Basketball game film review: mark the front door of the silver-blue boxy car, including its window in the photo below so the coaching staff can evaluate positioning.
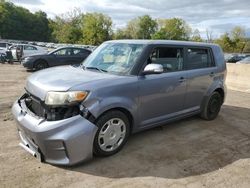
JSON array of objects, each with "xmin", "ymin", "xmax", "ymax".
[{"xmin": 138, "ymin": 46, "xmax": 187, "ymax": 127}]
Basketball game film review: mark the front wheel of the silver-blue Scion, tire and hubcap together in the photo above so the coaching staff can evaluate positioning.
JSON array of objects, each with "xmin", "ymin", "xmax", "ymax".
[{"xmin": 94, "ymin": 110, "xmax": 130, "ymax": 156}]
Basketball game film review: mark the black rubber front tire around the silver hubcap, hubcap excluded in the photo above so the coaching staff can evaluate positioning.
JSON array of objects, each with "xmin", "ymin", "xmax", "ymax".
[{"xmin": 93, "ymin": 110, "xmax": 130, "ymax": 156}]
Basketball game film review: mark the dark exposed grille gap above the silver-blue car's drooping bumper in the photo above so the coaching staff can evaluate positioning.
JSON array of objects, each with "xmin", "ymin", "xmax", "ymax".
[{"xmin": 24, "ymin": 94, "xmax": 80, "ymax": 121}]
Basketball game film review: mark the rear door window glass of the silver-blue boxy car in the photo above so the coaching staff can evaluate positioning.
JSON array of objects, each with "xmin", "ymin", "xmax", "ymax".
[{"xmin": 187, "ymin": 48, "xmax": 214, "ymax": 69}]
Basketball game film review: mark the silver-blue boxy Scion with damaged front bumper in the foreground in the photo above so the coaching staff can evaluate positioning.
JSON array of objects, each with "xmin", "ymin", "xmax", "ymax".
[{"xmin": 12, "ymin": 40, "xmax": 226, "ymax": 165}]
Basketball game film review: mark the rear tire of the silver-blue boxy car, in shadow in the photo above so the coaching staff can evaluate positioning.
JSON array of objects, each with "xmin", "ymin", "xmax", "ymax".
[{"xmin": 200, "ymin": 91, "xmax": 222, "ymax": 121}]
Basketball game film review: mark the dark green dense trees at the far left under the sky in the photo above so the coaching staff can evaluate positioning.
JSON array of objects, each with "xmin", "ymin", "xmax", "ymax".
[{"xmin": 0, "ymin": 0, "xmax": 51, "ymax": 41}]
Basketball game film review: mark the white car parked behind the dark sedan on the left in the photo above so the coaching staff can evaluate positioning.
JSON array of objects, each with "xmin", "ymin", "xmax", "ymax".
[{"xmin": 9, "ymin": 44, "xmax": 48, "ymax": 60}]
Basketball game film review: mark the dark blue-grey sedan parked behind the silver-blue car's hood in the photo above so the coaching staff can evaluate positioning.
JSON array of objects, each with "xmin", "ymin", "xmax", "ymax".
[{"xmin": 21, "ymin": 47, "xmax": 91, "ymax": 70}]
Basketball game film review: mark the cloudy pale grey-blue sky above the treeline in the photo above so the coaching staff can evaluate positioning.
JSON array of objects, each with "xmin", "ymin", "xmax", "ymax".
[{"xmin": 8, "ymin": 0, "xmax": 250, "ymax": 37}]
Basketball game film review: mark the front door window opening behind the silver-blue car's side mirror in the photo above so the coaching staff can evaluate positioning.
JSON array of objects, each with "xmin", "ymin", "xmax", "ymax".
[{"xmin": 149, "ymin": 47, "xmax": 183, "ymax": 72}]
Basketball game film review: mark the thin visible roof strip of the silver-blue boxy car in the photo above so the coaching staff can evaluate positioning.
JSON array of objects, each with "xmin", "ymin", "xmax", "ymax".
[{"xmin": 105, "ymin": 39, "xmax": 218, "ymax": 47}]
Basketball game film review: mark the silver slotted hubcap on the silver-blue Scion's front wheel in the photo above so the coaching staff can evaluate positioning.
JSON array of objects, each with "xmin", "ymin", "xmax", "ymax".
[{"xmin": 98, "ymin": 118, "xmax": 126, "ymax": 151}]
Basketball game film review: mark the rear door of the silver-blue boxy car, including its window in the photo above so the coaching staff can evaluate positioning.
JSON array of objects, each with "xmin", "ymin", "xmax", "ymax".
[{"xmin": 185, "ymin": 47, "xmax": 217, "ymax": 110}]
